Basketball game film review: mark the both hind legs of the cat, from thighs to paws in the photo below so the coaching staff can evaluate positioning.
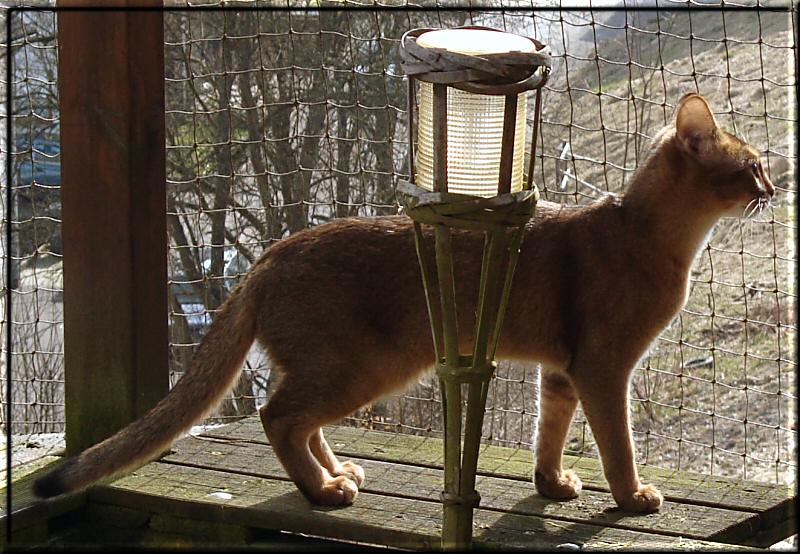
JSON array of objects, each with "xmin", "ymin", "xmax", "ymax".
[{"xmin": 260, "ymin": 317, "xmax": 433, "ymax": 504}]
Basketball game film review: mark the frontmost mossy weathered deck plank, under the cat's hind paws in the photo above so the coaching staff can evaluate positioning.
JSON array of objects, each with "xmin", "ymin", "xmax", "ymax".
[{"xmin": 94, "ymin": 462, "xmax": 752, "ymax": 550}]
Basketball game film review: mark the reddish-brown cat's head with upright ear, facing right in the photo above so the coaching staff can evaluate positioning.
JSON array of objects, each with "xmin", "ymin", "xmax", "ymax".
[{"xmin": 674, "ymin": 93, "xmax": 775, "ymax": 216}]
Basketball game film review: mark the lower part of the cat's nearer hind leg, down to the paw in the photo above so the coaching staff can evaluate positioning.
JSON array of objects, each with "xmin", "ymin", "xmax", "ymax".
[{"xmin": 259, "ymin": 383, "xmax": 358, "ymax": 506}]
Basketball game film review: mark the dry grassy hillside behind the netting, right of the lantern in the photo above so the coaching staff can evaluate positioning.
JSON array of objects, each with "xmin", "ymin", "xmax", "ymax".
[{"xmin": 536, "ymin": 8, "xmax": 796, "ymax": 480}]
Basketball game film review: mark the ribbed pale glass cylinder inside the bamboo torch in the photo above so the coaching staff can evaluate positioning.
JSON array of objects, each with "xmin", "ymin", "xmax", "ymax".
[{"xmin": 416, "ymin": 81, "xmax": 528, "ymax": 197}]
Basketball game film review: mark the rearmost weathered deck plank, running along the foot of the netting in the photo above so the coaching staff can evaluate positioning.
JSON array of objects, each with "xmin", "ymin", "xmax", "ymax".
[{"xmin": 204, "ymin": 418, "xmax": 796, "ymax": 522}]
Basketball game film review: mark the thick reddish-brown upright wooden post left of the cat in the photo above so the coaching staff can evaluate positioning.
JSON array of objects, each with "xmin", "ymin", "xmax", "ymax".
[{"xmin": 58, "ymin": 0, "xmax": 169, "ymax": 455}]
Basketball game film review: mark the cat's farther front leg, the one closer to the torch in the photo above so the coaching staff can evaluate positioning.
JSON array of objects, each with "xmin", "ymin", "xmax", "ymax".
[{"xmin": 534, "ymin": 367, "xmax": 582, "ymax": 500}]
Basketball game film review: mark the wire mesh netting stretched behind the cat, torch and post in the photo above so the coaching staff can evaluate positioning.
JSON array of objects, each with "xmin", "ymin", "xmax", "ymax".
[{"xmin": 0, "ymin": 2, "xmax": 797, "ymax": 490}]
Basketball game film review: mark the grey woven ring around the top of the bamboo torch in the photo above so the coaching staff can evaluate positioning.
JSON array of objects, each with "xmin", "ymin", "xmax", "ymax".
[{"xmin": 400, "ymin": 26, "xmax": 551, "ymax": 95}]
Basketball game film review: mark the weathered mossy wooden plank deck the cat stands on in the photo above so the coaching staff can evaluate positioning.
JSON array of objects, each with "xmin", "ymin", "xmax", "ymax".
[{"xmin": 3, "ymin": 418, "xmax": 797, "ymax": 550}]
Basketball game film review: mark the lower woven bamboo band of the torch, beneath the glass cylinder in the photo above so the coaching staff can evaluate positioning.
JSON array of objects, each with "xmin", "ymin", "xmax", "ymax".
[{"xmin": 397, "ymin": 181, "xmax": 539, "ymax": 231}]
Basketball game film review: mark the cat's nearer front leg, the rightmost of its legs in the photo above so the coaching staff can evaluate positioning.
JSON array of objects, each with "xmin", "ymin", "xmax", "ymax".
[{"xmin": 570, "ymin": 356, "xmax": 664, "ymax": 512}]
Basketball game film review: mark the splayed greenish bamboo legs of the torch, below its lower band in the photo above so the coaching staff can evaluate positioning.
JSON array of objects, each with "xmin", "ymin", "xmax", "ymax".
[{"xmin": 415, "ymin": 223, "xmax": 523, "ymax": 550}]
